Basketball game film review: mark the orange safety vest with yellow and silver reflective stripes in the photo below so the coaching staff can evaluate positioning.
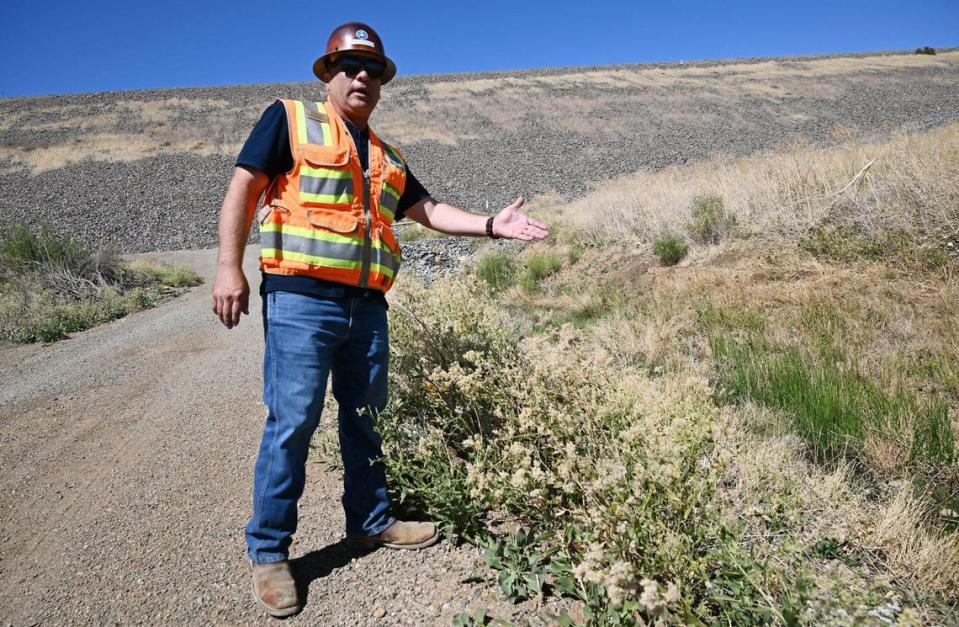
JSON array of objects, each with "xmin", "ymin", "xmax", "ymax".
[{"xmin": 260, "ymin": 100, "xmax": 406, "ymax": 292}]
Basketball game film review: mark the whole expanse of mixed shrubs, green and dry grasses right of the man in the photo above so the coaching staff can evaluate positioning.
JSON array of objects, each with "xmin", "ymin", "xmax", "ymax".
[{"xmin": 378, "ymin": 121, "xmax": 959, "ymax": 625}]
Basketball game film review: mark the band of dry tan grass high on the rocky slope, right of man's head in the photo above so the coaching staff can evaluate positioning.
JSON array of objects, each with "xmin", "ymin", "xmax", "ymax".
[{"xmin": 378, "ymin": 52, "xmax": 959, "ymax": 144}]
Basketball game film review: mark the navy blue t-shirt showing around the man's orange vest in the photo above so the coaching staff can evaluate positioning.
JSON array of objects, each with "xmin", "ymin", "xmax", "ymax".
[{"xmin": 236, "ymin": 102, "xmax": 430, "ymax": 298}]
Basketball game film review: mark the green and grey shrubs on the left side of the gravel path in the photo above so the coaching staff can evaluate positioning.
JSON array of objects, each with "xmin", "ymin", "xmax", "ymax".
[{"xmin": 0, "ymin": 225, "xmax": 201, "ymax": 342}]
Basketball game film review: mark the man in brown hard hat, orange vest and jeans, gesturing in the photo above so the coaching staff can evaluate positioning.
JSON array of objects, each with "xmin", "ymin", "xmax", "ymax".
[{"xmin": 213, "ymin": 23, "xmax": 547, "ymax": 616}]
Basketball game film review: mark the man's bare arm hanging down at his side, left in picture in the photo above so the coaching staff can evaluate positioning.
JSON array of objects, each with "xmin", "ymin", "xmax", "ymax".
[{"xmin": 213, "ymin": 166, "xmax": 270, "ymax": 329}]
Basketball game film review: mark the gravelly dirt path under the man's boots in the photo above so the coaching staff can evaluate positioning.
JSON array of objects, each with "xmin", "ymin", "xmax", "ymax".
[{"xmin": 0, "ymin": 251, "xmax": 564, "ymax": 625}]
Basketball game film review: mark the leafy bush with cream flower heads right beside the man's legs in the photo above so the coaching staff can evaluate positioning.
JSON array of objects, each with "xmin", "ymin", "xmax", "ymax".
[{"xmin": 378, "ymin": 286, "xmax": 844, "ymax": 625}]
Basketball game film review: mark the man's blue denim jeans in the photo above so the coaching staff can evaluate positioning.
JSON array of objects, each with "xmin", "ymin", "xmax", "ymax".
[{"xmin": 246, "ymin": 292, "xmax": 394, "ymax": 564}]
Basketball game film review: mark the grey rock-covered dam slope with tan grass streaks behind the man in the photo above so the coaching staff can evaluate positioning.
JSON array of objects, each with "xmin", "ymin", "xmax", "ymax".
[{"xmin": 0, "ymin": 50, "xmax": 959, "ymax": 252}]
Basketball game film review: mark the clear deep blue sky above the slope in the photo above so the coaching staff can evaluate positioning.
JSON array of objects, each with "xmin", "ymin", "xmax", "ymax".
[{"xmin": 0, "ymin": 0, "xmax": 959, "ymax": 97}]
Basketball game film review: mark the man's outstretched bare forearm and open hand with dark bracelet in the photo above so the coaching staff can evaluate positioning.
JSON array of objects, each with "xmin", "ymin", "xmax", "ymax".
[{"xmin": 405, "ymin": 196, "xmax": 549, "ymax": 240}]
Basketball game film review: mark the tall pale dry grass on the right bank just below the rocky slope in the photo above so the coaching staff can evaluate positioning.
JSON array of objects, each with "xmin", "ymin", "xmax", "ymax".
[{"xmin": 560, "ymin": 124, "xmax": 959, "ymax": 248}]
